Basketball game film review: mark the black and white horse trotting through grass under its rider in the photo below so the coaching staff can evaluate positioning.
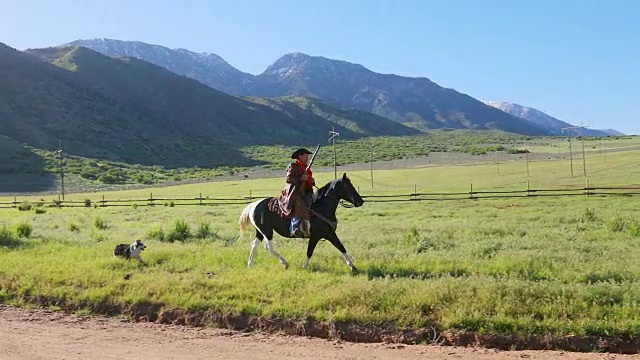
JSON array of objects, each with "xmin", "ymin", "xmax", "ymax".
[{"xmin": 238, "ymin": 173, "xmax": 364, "ymax": 273}]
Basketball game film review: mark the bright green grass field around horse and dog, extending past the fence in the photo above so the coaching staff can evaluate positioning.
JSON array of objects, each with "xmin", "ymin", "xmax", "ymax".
[{"xmin": 0, "ymin": 140, "xmax": 640, "ymax": 346}]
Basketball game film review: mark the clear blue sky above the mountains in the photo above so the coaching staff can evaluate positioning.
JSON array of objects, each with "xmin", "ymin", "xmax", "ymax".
[{"xmin": 0, "ymin": 0, "xmax": 640, "ymax": 134}]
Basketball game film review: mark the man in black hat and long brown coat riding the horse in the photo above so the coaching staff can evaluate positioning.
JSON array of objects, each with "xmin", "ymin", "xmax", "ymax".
[{"xmin": 279, "ymin": 148, "xmax": 315, "ymax": 237}]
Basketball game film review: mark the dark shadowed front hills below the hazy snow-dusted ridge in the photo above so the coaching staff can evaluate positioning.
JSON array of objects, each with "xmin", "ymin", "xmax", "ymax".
[{"xmin": 0, "ymin": 44, "xmax": 418, "ymax": 167}]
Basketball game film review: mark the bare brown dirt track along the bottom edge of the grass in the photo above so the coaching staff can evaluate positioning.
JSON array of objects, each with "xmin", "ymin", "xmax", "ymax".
[{"xmin": 0, "ymin": 305, "xmax": 638, "ymax": 360}]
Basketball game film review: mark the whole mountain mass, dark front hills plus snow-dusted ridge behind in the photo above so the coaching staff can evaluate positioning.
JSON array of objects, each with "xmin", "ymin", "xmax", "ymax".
[{"xmin": 0, "ymin": 39, "xmax": 620, "ymax": 174}]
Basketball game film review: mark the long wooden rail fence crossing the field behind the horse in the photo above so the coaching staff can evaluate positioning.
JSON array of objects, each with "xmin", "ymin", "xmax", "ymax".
[{"xmin": 0, "ymin": 184, "xmax": 640, "ymax": 209}]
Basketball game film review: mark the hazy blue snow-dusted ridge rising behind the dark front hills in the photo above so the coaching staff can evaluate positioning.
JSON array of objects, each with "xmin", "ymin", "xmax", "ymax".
[{"xmin": 65, "ymin": 39, "xmax": 549, "ymax": 135}]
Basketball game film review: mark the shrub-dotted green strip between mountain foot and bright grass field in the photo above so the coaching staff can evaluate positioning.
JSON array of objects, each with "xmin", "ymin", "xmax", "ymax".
[{"xmin": 7, "ymin": 130, "xmax": 640, "ymax": 193}]
